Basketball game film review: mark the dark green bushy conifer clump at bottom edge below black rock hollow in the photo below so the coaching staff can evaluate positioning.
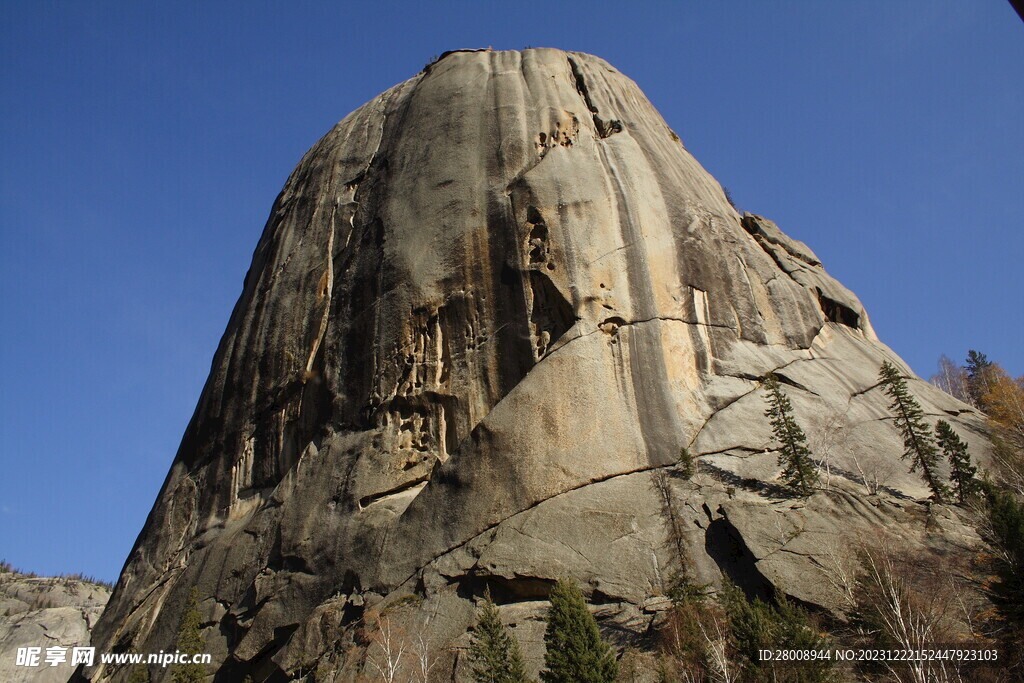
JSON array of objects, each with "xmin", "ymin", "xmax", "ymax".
[{"xmin": 721, "ymin": 583, "xmax": 835, "ymax": 683}]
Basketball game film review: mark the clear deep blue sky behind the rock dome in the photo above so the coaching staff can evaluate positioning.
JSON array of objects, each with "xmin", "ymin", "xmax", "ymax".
[{"xmin": 0, "ymin": 0, "xmax": 1024, "ymax": 580}]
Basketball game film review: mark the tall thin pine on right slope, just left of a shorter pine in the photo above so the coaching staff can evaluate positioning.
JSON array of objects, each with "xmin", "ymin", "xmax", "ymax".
[{"xmin": 879, "ymin": 360, "xmax": 949, "ymax": 503}]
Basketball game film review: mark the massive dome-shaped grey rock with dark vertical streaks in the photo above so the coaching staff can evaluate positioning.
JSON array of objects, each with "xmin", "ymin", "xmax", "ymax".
[{"xmin": 86, "ymin": 49, "xmax": 984, "ymax": 681}]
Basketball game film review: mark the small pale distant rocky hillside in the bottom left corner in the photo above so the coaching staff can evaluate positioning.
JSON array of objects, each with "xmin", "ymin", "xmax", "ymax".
[{"xmin": 0, "ymin": 570, "xmax": 111, "ymax": 683}]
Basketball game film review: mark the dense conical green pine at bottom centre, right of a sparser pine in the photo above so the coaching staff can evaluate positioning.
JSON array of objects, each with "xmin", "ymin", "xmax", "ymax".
[{"xmin": 541, "ymin": 579, "xmax": 618, "ymax": 683}]
